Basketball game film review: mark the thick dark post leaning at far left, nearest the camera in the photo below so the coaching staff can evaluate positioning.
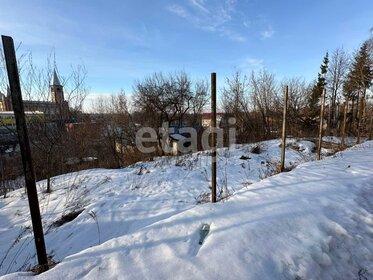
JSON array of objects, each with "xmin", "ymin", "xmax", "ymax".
[{"xmin": 1, "ymin": 35, "xmax": 48, "ymax": 271}]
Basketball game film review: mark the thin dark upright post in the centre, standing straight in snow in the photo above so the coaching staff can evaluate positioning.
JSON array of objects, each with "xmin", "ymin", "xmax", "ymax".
[{"xmin": 211, "ymin": 73, "xmax": 216, "ymax": 203}]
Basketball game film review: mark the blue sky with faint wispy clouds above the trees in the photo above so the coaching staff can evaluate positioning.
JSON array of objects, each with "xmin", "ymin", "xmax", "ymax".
[{"xmin": 0, "ymin": 0, "xmax": 373, "ymax": 107}]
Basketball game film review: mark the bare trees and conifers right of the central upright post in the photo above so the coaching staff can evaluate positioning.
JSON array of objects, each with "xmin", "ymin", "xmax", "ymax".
[{"xmin": 222, "ymin": 31, "xmax": 373, "ymax": 142}]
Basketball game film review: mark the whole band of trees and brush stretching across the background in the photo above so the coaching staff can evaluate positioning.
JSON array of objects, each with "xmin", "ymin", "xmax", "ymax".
[{"xmin": 0, "ymin": 30, "xmax": 373, "ymax": 191}]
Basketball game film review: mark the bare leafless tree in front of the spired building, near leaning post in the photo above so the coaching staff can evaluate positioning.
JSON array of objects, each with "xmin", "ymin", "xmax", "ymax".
[{"xmin": 0, "ymin": 48, "xmax": 88, "ymax": 192}]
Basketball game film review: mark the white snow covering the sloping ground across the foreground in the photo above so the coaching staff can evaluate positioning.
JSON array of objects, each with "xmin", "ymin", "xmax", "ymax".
[{"xmin": 0, "ymin": 139, "xmax": 373, "ymax": 280}]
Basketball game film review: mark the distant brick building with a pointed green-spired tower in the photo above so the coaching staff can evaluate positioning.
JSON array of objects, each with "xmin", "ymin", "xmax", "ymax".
[{"xmin": 0, "ymin": 70, "xmax": 69, "ymax": 121}]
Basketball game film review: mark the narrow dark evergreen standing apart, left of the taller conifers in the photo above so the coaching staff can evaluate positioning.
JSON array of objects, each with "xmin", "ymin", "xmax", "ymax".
[{"xmin": 308, "ymin": 53, "xmax": 329, "ymax": 118}]
